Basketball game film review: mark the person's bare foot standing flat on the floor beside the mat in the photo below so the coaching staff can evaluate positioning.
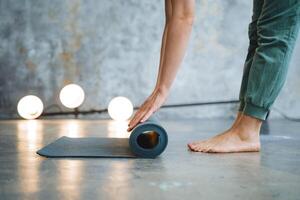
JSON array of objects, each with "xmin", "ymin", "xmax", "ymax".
[{"xmin": 188, "ymin": 114, "xmax": 262, "ymax": 153}]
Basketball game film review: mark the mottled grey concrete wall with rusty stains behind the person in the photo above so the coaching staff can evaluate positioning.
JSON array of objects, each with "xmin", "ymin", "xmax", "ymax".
[{"xmin": 0, "ymin": 0, "xmax": 300, "ymax": 118}]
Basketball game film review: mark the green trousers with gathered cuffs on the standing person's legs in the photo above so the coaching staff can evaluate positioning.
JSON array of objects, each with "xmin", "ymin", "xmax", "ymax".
[{"xmin": 239, "ymin": 0, "xmax": 300, "ymax": 120}]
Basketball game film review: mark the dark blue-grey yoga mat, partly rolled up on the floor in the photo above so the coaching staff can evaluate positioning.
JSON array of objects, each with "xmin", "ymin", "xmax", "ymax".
[{"xmin": 37, "ymin": 117, "xmax": 168, "ymax": 158}]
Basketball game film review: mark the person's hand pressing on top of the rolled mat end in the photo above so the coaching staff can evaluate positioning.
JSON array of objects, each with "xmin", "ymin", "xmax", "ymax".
[{"xmin": 127, "ymin": 91, "xmax": 167, "ymax": 131}]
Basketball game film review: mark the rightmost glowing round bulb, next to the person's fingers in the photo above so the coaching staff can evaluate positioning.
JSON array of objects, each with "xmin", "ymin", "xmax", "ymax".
[{"xmin": 108, "ymin": 97, "xmax": 133, "ymax": 121}]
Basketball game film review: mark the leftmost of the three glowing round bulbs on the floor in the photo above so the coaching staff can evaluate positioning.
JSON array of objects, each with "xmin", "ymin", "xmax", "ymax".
[{"xmin": 17, "ymin": 95, "xmax": 44, "ymax": 119}]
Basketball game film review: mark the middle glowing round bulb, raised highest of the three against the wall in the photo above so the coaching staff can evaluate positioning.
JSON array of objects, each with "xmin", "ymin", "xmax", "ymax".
[{"xmin": 59, "ymin": 84, "xmax": 84, "ymax": 108}]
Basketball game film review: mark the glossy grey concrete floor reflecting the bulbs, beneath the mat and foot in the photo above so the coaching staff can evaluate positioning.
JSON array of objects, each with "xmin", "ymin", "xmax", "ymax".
[{"xmin": 0, "ymin": 120, "xmax": 300, "ymax": 200}]
